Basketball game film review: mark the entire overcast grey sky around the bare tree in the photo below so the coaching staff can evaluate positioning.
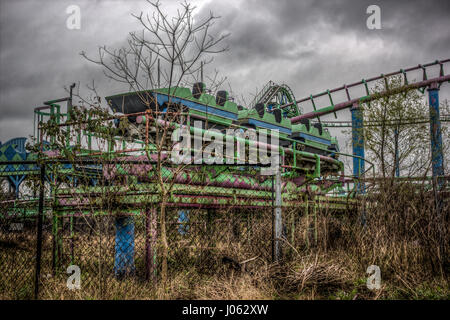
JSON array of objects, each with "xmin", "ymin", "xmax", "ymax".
[{"xmin": 0, "ymin": 0, "xmax": 450, "ymax": 162}]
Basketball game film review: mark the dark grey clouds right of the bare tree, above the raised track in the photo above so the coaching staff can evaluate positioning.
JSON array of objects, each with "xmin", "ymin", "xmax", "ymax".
[{"xmin": 197, "ymin": 0, "xmax": 450, "ymax": 95}]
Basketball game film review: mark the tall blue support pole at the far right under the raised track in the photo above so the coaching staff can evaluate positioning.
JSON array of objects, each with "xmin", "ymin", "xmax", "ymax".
[{"xmin": 428, "ymin": 83, "xmax": 444, "ymax": 187}]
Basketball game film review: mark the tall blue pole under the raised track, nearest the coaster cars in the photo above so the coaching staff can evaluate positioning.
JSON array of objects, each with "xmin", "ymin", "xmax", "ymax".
[{"xmin": 350, "ymin": 103, "xmax": 364, "ymax": 193}]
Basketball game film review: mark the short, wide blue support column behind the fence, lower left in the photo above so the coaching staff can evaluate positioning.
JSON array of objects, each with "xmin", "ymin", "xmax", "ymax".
[{"xmin": 114, "ymin": 217, "xmax": 135, "ymax": 277}]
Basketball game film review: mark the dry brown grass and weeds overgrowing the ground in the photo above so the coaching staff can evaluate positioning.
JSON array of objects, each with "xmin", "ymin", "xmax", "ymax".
[{"xmin": 0, "ymin": 180, "xmax": 450, "ymax": 300}]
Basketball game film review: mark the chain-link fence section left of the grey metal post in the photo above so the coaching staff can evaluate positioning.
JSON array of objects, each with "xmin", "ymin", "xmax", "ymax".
[{"xmin": 0, "ymin": 160, "xmax": 286, "ymax": 299}]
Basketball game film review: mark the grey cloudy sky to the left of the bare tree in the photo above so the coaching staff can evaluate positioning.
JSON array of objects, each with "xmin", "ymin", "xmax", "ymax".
[{"xmin": 0, "ymin": 0, "xmax": 141, "ymax": 141}]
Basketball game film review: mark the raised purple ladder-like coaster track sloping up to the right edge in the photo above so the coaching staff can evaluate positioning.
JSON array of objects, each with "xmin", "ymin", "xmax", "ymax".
[{"xmin": 280, "ymin": 59, "xmax": 450, "ymax": 124}]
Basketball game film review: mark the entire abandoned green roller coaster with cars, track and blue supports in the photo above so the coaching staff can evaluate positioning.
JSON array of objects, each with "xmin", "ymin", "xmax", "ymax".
[{"xmin": 0, "ymin": 59, "xmax": 450, "ymax": 272}]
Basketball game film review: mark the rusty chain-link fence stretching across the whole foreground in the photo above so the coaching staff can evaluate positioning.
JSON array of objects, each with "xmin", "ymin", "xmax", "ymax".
[{"xmin": 6, "ymin": 158, "xmax": 442, "ymax": 300}]
